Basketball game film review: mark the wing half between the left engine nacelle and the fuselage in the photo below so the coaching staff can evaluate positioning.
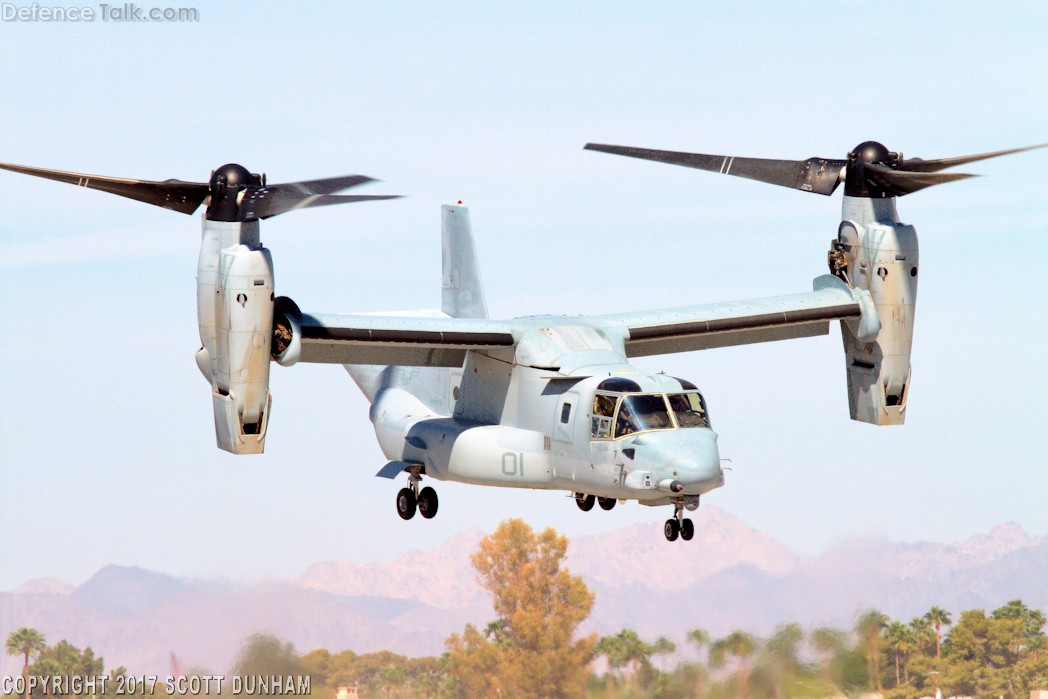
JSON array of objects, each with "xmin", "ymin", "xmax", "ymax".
[{"xmin": 296, "ymin": 313, "xmax": 516, "ymax": 367}]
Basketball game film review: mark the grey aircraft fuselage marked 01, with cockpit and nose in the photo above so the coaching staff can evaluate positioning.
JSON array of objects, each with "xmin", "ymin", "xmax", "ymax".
[{"xmin": 349, "ymin": 326, "xmax": 724, "ymax": 507}]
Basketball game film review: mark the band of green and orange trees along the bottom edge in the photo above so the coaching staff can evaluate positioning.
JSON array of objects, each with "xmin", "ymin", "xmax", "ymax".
[{"xmin": 3, "ymin": 553, "xmax": 1048, "ymax": 699}]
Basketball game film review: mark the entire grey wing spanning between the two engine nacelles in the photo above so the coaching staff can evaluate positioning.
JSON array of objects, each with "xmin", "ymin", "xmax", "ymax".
[{"xmin": 275, "ymin": 275, "xmax": 880, "ymax": 367}]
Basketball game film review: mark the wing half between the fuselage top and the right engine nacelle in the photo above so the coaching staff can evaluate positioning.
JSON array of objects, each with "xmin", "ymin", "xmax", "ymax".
[{"xmin": 588, "ymin": 275, "xmax": 880, "ymax": 356}]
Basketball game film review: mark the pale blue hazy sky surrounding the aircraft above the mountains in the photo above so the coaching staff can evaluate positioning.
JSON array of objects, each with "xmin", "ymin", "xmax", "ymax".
[{"xmin": 0, "ymin": 0, "xmax": 1048, "ymax": 590}]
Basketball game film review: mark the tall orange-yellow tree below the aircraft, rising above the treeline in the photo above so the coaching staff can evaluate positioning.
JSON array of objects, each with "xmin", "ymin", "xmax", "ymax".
[{"xmin": 446, "ymin": 520, "xmax": 596, "ymax": 697}]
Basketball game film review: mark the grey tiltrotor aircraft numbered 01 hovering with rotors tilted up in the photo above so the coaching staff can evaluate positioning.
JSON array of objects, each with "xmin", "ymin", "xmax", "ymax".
[{"xmin": 0, "ymin": 141, "xmax": 1041, "ymax": 541}]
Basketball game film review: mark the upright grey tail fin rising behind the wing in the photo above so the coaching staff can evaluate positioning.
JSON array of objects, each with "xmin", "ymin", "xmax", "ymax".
[{"xmin": 440, "ymin": 204, "xmax": 487, "ymax": 318}]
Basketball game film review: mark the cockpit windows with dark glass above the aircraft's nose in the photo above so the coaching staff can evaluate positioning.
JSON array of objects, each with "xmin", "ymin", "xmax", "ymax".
[{"xmin": 590, "ymin": 377, "xmax": 709, "ymax": 439}]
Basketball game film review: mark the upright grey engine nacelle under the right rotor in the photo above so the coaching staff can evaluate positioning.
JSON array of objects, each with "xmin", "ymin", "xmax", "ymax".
[{"xmin": 834, "ymin": 196, "xmax": 918, "ymax": 424}]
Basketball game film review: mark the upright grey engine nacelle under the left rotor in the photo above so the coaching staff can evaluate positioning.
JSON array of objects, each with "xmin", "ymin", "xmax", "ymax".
[{"xmin": 197, "ymin": 220, "xmax": 274, "ymax": 454}]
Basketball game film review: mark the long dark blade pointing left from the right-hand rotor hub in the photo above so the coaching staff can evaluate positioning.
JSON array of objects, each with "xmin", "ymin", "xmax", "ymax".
[{"xmin": 586, "ymin": 144, "xmax": 848, "ymax": 196}]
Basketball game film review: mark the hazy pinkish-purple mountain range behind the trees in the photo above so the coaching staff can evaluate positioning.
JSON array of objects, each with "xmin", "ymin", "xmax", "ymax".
[{"xmin": 0, "ymin": 507, "xmax": 1048, "ymax": 675}]
